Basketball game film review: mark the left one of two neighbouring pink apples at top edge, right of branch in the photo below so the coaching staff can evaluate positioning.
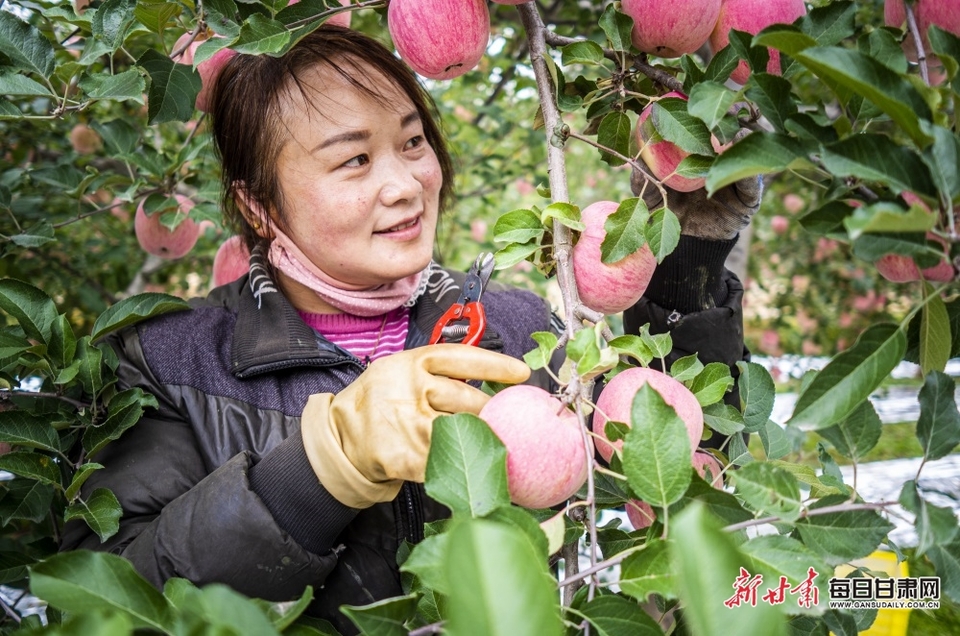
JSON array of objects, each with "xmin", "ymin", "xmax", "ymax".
[{"xmin": 621, "ymin": 0, "xmax": 720, "ymax": 57}]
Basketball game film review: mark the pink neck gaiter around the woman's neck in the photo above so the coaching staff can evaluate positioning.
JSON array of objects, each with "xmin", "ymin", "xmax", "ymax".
[{"xmin": 267, "ymin": 223, "xmax": 430, "ymax": 316}]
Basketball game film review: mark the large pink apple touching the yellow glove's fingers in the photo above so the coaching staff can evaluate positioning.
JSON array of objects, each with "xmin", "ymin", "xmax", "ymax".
[{"xmin": 480, "ymin": 385, "xmax": 593, "ymax": 508}]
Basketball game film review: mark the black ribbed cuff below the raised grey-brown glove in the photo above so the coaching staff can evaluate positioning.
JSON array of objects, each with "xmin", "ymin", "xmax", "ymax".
[{"xmin": 643, "ymin": 235, "xmax": 737, "ymax": 314}]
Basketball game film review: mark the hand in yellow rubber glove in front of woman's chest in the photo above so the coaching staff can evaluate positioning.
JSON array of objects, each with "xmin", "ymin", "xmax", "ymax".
[{"xmin": 300, "ymin": 344, "xmax": 530, "ymax": 508}]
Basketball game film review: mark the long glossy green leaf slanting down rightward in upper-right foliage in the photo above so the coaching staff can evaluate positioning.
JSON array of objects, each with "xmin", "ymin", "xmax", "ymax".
[{"xmin": 793, "ymin": 46, "xmax": 932, "ymax": 147}]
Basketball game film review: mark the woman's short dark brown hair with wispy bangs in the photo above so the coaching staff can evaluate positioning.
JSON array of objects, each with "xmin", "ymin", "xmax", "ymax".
[{"xmin": 211, "ymin": 25, "xmax": 453, "ymax": 250}]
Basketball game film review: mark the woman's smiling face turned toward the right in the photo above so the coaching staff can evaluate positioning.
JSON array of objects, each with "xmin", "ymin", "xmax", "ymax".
[{"xmin": 277, "ymin": 67, "xmax": 443, "ymax": 287}]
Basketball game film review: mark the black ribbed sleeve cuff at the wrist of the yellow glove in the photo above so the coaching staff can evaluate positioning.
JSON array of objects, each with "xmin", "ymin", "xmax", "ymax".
[{"xmin": 248, "ymin": 434, "xmax": 359, "ymax": 554}]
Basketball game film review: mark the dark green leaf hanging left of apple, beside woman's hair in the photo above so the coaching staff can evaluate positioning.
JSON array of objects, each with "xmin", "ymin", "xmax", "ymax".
[{"xmin": 137, "ymin": 49, "xmax": 202, "ymax": 124}]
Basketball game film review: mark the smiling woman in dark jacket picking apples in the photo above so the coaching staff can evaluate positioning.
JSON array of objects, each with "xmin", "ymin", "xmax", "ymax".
[{"xmin": 62, "ymin": 26, "xmax": 756, "ymax": 633}]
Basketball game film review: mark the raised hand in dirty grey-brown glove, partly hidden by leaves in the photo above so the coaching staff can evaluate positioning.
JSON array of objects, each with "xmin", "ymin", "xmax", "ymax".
[{"xmin": 630, "ymin": 129, "xmax": 763, "ymax": 240}]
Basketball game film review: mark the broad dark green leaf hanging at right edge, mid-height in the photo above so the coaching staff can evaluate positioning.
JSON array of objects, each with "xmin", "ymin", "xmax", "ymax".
[{"xmin": 917, "ymin": 371, "xmax": 960, "ymax": 461}]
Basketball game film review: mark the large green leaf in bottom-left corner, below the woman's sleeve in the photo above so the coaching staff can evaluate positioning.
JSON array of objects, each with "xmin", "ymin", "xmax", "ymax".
[{"xmin": 30, "ymin": 550, "xmax": 173, "ymax": 633}]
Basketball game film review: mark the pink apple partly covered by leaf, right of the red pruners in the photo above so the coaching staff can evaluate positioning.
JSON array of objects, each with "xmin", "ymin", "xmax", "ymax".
[{"xmin": 573, "ymin": 201, "xmax": 657, "ymax": 314}]
